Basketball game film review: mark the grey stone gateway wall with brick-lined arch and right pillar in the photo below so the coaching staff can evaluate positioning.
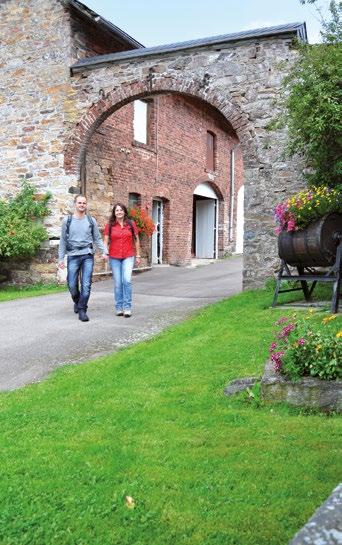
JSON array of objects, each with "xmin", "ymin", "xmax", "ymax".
[{"xmin": 66, "ymin": 37, "xmax": 302, "ymax": 287}]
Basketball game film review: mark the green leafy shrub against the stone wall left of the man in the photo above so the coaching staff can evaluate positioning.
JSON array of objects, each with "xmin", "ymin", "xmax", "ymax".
[{"xmin": 0, "ymin": 182, "xmax": 51, "ymax": 259}]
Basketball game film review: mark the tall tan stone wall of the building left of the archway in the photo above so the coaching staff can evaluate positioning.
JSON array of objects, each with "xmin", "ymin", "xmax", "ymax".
[{"xmin": 0, "ymin": 0, "xmax": 77, "ymax": 232}]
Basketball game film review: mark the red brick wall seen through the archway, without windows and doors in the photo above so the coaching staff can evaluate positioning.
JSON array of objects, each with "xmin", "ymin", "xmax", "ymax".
[{"xmin": 86, "ymin": 95, "xmax": 243, "ymax": 264}]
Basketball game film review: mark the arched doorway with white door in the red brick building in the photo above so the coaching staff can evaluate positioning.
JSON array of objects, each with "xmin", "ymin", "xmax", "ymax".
[{"xmin": 192, "ymin": 183, "xmax": 219, "ymax": 259}]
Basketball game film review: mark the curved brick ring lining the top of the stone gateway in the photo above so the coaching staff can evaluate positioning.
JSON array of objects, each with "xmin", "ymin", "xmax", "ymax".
[{"xmin": 64, "ymin": 76, "xmax": 253, "ymax": 179}]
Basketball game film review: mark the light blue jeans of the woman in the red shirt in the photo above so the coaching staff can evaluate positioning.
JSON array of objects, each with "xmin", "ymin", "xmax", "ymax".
[{"xmin": 109, "ymin": 257, "xmax": 134, "ymax": 310}]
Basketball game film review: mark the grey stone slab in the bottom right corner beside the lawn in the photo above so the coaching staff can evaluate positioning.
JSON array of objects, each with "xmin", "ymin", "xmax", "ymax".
[{"xmin": 289, "ymin": 483, "xmax": 342, "ymax": 545}]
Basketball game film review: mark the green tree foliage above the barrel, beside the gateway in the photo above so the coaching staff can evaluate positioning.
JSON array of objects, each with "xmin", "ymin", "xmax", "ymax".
[{"xmin": 284, "ymin": 0, "xmax": 342, "ymax": 187}]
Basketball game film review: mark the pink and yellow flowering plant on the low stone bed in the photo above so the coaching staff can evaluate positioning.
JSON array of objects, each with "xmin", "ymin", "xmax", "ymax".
[{"xmin": 269, "ymin": 312, "xmax": 342, "ymax": 380}]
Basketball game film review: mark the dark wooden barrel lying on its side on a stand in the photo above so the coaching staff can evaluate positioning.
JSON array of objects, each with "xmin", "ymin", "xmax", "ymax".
[{"xmin": 278, "ymin": 214, "xmax": 342, "ymax": 267}]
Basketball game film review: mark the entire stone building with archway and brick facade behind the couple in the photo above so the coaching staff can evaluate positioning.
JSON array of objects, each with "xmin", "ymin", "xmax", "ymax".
[{"xmin": 0, "ymin": 0, "xmax": 306, "ymax": 286}]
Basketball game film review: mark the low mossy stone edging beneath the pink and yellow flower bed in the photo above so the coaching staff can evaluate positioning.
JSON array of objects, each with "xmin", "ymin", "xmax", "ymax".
[{"xmin": 261, "ymin": 361, "xmax": 342, "ymax": 412}]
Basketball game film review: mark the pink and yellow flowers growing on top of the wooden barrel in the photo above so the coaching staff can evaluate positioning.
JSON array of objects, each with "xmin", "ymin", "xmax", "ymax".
[{"xmin": 274, "ymin": 185, "xmax": 342, "ymax": 235}]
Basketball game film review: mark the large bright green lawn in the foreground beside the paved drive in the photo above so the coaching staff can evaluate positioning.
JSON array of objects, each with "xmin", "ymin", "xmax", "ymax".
[{"xmin": 0, "ymin": 291, "xmax": 342, "ymax": 545}]
